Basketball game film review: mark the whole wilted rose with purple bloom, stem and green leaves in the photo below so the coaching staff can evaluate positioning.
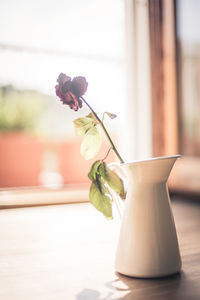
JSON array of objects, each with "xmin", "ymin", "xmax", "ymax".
[{"xmin": 55, "ymin": 73, "xmax": 125, "ymax": 219}]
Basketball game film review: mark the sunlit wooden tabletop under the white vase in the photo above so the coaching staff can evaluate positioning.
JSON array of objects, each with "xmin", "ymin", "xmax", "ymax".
[{"xmin": 0, "ymin": 199, "xmax": 200, "ymax": 300}]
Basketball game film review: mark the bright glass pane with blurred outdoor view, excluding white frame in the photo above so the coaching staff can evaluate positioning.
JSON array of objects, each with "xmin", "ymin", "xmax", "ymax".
[{"xmin": 0, "ymin": 0, "xmax": 126, "ymax": 192}]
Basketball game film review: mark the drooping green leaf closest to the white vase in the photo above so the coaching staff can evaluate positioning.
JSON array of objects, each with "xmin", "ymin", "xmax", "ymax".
[{"xmin": 98, "ymin": 163, "xmax": 125, "ymax": 199}]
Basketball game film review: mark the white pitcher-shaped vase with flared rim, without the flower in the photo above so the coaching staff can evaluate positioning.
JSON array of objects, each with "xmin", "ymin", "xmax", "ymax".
[{"xmin": 115, "ymin": 155, "xmax": 181, "ymax": 278}]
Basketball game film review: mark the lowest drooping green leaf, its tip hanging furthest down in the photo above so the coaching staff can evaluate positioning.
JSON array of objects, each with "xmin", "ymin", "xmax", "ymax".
[{"xmin": 89, "ymin": 182, "xmax": 112, "ymax": 219}]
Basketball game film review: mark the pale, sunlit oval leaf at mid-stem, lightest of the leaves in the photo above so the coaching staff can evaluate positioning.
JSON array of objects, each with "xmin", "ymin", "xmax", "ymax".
[{"xmin": 80, "ymin": 127, "xmax": 101, "ymax": 160}]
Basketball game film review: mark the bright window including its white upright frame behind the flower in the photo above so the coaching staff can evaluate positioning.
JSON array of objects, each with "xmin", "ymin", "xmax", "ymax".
[{"xmin": 0, "ymin": 0, "xmax": 151, "ymax": 205}]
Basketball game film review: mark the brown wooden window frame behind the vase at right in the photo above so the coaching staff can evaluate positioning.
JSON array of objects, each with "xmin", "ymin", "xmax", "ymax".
[{"xmin": 149, "ymin": 0, "xmax": 200, "ymax": 197}]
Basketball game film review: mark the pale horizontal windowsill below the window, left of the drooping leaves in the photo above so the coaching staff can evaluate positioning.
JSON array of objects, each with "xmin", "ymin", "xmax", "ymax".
[{"xmin": 0, "ymin": 185, "xmax": 89, "ymax": 208}]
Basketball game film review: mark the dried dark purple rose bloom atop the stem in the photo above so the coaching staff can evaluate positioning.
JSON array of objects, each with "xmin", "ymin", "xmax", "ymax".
[{"xmin": 55, "ymin": 73, "xmax": 88, "ymax": 111}]
